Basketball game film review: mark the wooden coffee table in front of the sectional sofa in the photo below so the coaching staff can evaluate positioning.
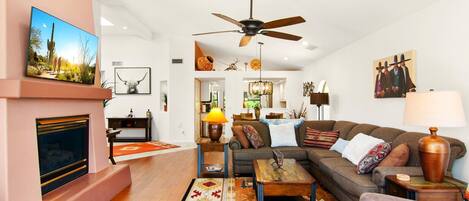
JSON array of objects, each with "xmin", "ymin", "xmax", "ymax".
[{"xmin": 253, "ymin": 159, "xmax": 317, "ymax": 201}]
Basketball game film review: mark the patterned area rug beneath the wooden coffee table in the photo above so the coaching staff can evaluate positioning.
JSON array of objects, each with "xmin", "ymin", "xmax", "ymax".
[{"xmin": 182, "ymin": 177, "xmax": 336, "ymax": 201}]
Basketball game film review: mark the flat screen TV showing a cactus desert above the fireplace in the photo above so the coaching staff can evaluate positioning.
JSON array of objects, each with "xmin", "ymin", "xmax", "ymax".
[{"xmin": 26, "ymin": 7, "xmax": 98, "ymax": 85}]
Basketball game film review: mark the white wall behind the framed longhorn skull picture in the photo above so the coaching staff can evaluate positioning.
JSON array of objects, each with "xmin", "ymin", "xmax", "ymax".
[{"xmin": 101, "ymin": 35, "xmax": 169, "ymax": 139}]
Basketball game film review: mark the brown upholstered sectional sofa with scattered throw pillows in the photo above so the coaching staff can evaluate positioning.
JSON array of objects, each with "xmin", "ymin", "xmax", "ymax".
[{"xmin": 230, "ymin": 121, "xmax": 466, "ymax": 201}]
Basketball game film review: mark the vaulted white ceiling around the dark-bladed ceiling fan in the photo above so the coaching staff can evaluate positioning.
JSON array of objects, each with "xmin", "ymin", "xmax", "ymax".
[{"xmin": 100, "ymin": 0, "xmax": 438, "ymax": 70}]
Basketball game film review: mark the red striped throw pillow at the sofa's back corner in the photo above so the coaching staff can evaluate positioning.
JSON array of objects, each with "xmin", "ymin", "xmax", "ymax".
[{"xmin": 303, "ymin": 127, "xmax": 339, "ymax": 149}]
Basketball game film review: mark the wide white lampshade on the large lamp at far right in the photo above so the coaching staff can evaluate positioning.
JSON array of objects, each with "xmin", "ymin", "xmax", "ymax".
[{"xmin": 404, "ymin": 91, "xmax": 466, "ymax": 127}]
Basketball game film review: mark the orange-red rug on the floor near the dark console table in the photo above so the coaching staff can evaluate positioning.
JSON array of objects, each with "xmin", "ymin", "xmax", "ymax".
[{"xmin": 114, "ymin": 141, "xmax": 179, "ymax": 156}]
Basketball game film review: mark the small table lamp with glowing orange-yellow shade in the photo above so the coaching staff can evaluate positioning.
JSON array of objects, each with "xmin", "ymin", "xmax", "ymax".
[{"xmin": 202, "ymin": 107, "xmax": 228, "ymax": 142}]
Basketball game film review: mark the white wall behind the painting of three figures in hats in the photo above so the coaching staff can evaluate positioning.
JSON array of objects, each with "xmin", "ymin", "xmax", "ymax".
[{"xmin": 305, "ymin": 0, "xmax": 469, "ymax": 182}]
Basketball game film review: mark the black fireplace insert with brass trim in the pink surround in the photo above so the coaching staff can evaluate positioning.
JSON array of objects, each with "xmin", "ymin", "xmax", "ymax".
[{"xmin": 36, "ymin": 115, "xmax": 89, "ymax": 195}]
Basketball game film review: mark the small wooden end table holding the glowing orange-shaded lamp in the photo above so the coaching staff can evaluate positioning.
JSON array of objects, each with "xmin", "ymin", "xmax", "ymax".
[{"xmin": 196, "ymin": 136, "xmax": 229, "ymax": 178}]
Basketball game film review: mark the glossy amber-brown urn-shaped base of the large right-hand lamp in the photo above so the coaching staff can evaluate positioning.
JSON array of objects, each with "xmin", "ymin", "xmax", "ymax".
[{"xmin": 419, "ymin": 128, "xmax": 451, "ymax": 183}]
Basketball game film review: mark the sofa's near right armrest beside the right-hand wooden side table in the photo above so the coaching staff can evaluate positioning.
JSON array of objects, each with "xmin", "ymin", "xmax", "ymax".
[{"xmin": 371, "ymin": 167, "xmax": 423, "ymax": 187}]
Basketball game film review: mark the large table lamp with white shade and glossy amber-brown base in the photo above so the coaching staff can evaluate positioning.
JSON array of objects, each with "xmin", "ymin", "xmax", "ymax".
[{"xmin": 404, "ymin": 90, "xmax": 466, "ymax": 183}]
